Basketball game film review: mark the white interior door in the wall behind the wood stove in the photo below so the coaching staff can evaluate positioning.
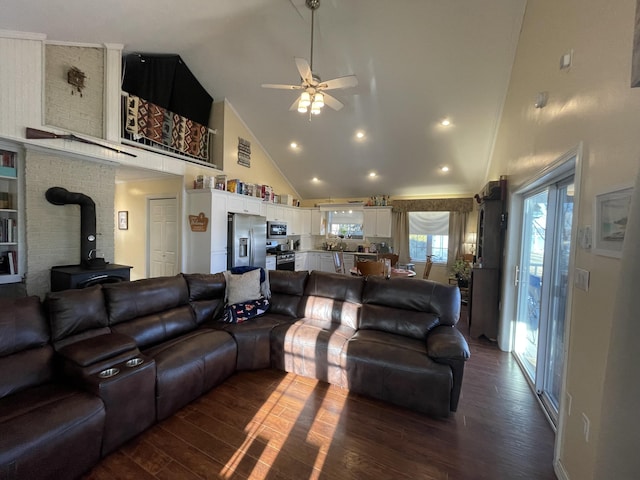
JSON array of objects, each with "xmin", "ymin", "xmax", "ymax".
[{"xmin": 147, "ymin": 198, "xmax": 178, "ymax": 277}]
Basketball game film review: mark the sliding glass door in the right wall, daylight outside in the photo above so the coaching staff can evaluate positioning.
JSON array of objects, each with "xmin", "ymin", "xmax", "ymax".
[{"xmin": 514, "ymin": 175, "xmax": 573, "ymax": 421}]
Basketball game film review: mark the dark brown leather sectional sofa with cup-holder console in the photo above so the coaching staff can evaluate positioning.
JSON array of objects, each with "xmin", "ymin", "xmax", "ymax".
[{"xmin": 0, "ymin": 271, "xmax": 469, "ymax": 480}]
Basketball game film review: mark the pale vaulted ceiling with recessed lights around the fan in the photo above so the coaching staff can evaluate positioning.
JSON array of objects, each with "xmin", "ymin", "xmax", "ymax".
[{"xmin": 0, "ymin": 0, "xmax": 533, "ymax": 198}]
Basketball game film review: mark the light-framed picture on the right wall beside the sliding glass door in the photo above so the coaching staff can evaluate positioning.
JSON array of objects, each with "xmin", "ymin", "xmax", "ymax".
[{"xmin": 593, "ymin": 187, "xmax": 633, "ymax": 258}]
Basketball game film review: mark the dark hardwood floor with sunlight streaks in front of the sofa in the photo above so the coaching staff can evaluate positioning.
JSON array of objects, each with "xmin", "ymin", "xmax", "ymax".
[{"xmin": 85, "ymin": 310, "xmax": 556, "ymax": 480}]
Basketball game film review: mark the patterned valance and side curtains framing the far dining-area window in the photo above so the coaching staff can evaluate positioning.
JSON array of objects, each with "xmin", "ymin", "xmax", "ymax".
[{"xmin": 392, "ymin": 198, "xmax": 474, "ymax": 268}]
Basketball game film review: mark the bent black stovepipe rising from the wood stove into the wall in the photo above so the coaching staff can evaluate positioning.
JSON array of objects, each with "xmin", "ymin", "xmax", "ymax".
[{"xmin": 45, "ymin": 187, "xmax": 105, "ymax": 269}]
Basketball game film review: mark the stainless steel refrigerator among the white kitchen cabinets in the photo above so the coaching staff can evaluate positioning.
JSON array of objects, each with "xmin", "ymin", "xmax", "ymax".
[{"xmin": 227, "ymin": 213, "xmax": 267, "ymax": 268}]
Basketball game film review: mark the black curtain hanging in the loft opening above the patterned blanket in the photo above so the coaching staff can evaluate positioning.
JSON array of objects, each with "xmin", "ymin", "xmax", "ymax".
[{"xmin": 122, "ymin": 53, "xmax": 213, "ymax": 126}]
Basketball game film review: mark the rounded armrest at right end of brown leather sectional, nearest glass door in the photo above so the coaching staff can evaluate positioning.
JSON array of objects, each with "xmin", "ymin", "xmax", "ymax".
[{"xmin": 427, "ymin": 325, "xmax": 471, "ymax": 412}]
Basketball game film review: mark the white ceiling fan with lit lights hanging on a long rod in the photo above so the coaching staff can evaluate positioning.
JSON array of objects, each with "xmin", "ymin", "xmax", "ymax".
[{"xmin": 262, "ymin": 0, "xmax": 358, "ymax": 118}]
